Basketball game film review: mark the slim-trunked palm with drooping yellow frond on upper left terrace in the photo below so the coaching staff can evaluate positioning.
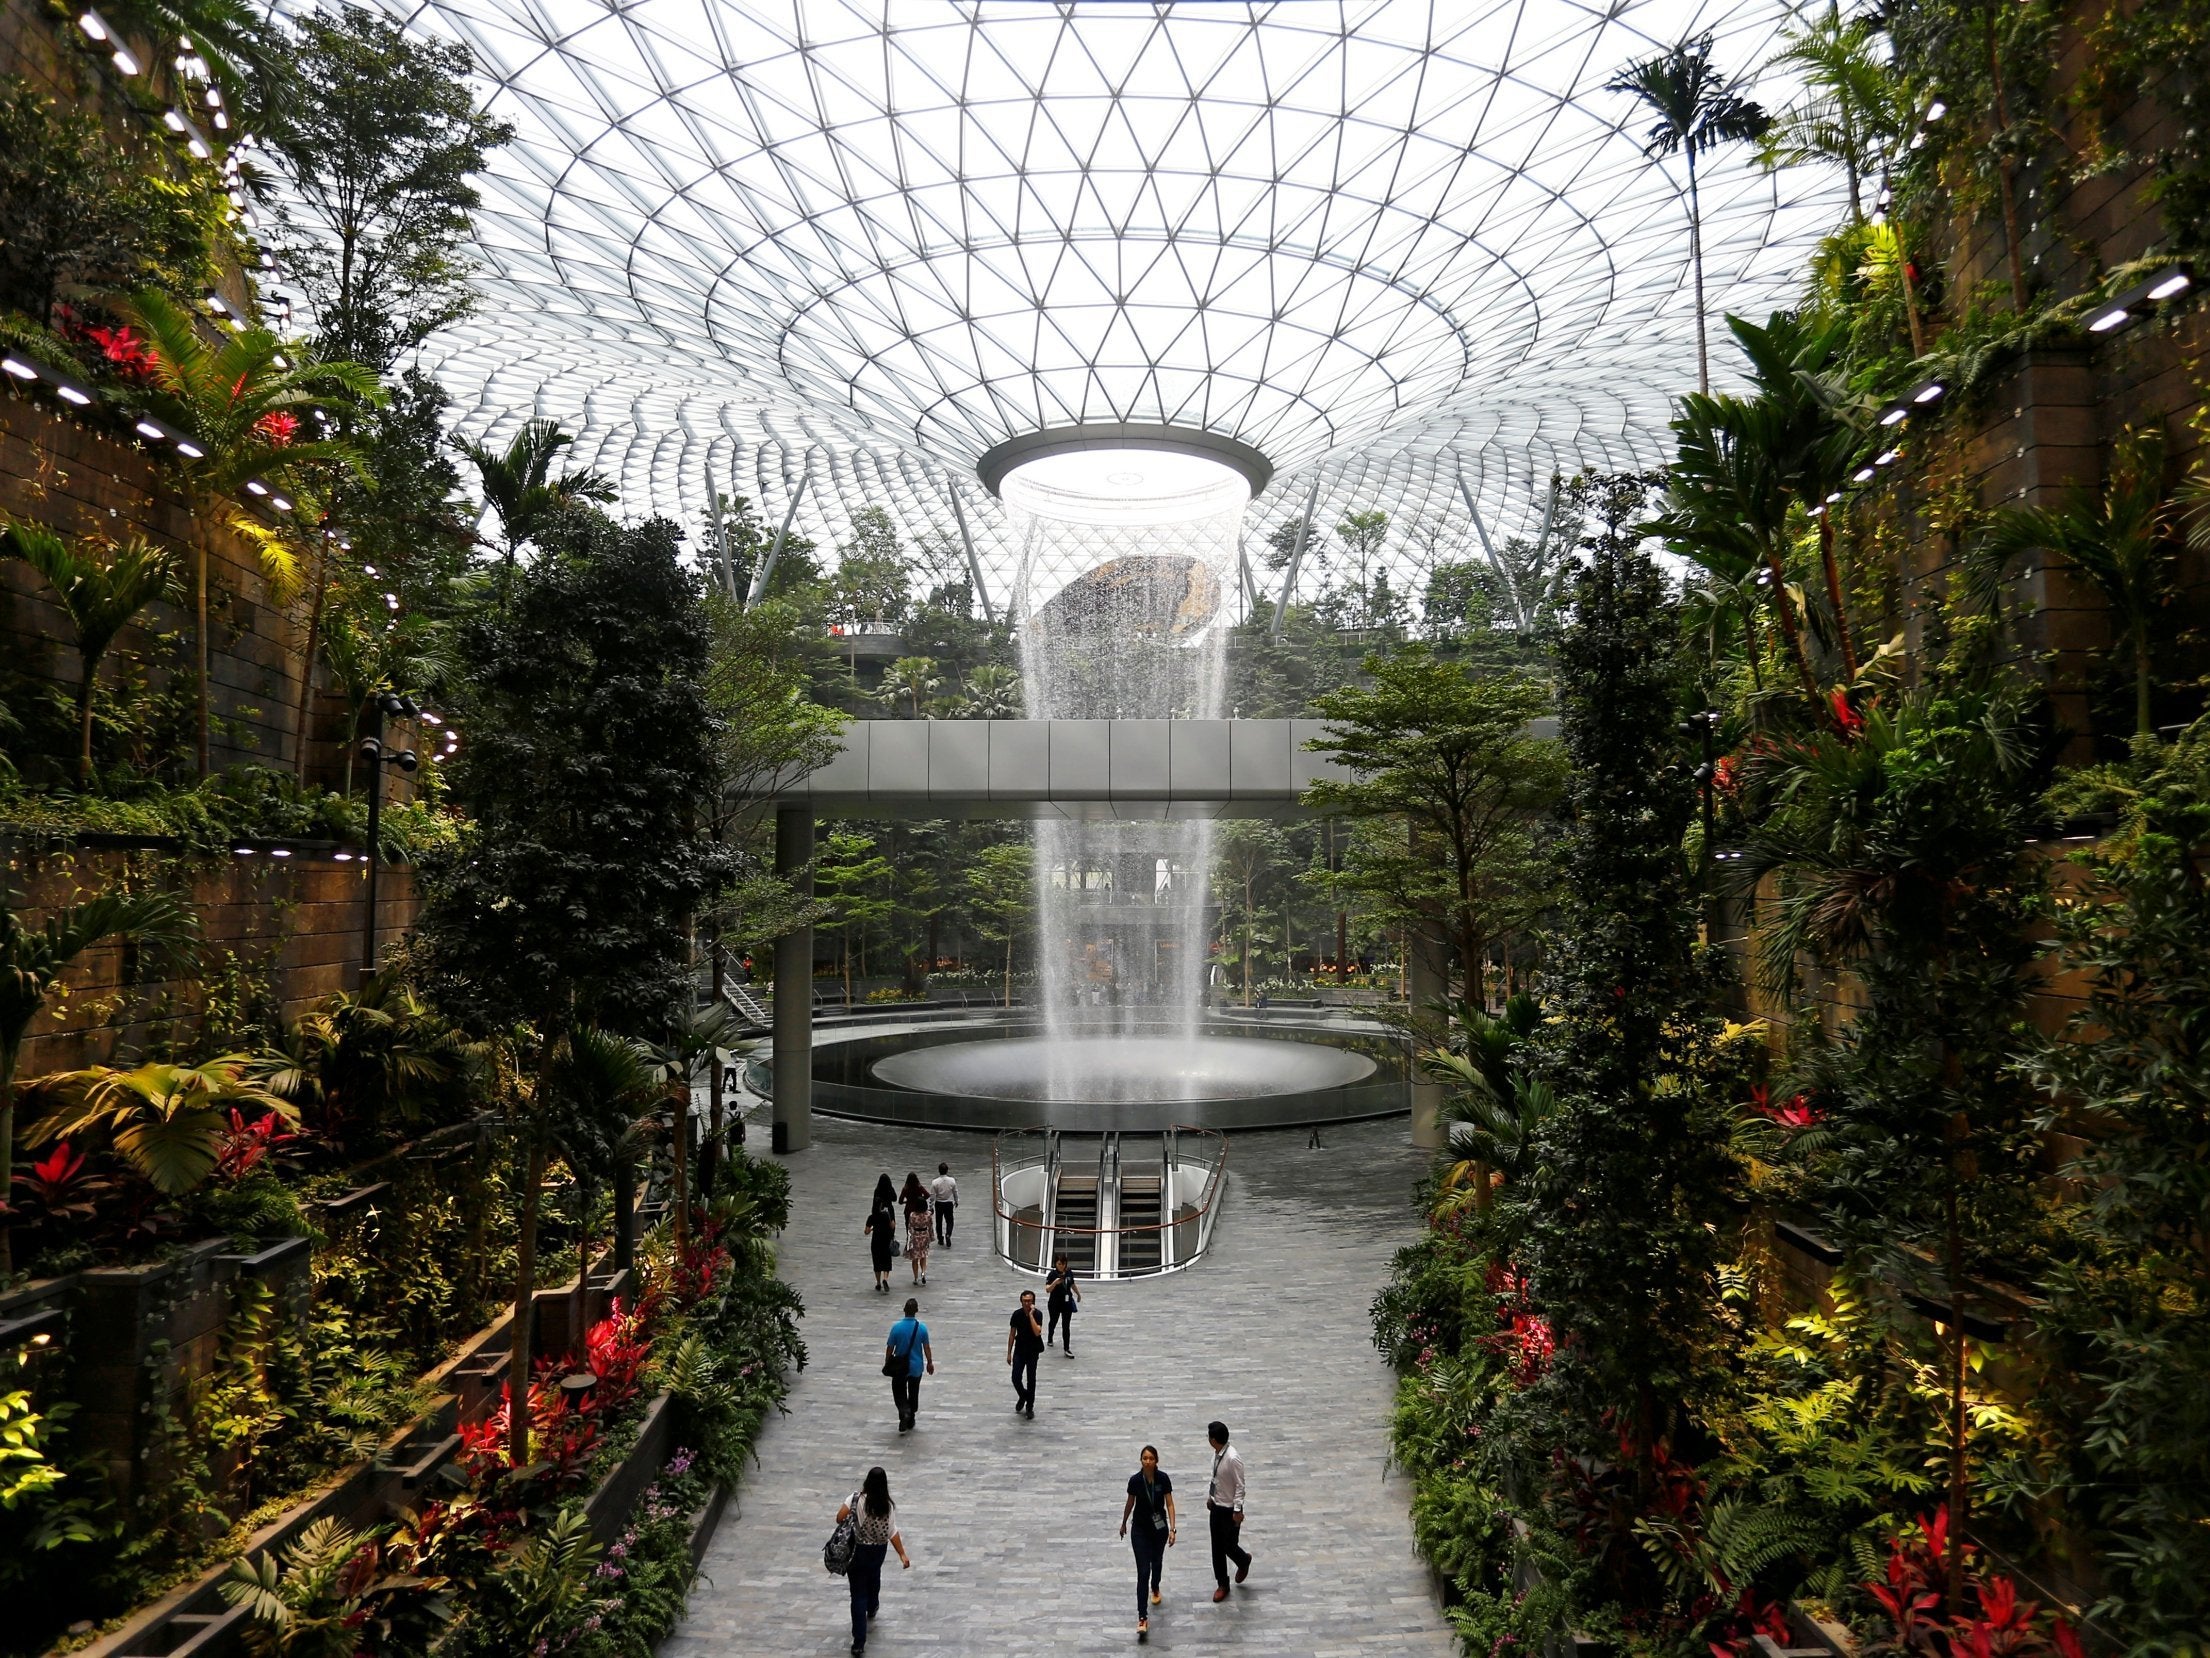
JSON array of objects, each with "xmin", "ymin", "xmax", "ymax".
[{"xmin": 128, "ymin": 290, "xmax": 385, "ymax": 776}]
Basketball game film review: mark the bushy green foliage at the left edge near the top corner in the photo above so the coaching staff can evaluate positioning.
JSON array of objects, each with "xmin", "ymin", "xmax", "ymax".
[{"xmin": 0, "ymin": 75, "xmax": 214, "ymax": 327}]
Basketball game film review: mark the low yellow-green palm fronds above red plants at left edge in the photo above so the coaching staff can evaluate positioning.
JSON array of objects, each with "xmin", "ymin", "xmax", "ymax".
[{"xmin": 31, "ymin": 1054, "xmax": 298, "ymax": 1198}]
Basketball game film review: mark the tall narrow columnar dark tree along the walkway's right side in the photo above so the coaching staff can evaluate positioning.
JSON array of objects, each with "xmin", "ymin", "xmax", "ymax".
[{"xmin": 1525, "ymin": 475, "xmax": 1728, "ymax": 1503}]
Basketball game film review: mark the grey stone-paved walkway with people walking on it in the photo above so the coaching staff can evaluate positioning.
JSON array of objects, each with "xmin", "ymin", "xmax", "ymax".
[{"xmin": 663, "ymin": 1112, "xmax": 1454, "ymax": 1658}]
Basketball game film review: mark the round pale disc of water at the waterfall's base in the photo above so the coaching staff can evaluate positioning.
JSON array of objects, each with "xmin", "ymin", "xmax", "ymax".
[{"xmin": 871, "ymin": 1035, "xmax": 1375, "ymax": 1105}]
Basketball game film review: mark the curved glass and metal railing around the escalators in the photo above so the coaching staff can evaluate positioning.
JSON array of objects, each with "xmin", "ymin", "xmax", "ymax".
[{"xmin": 990, "ymin": 1125, "xmax": 1229, "ymax": 1278}]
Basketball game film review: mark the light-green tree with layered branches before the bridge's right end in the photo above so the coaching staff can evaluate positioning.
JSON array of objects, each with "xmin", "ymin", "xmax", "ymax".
[{"xmin": 1306, "ymin": 643, "xmax": 1562, "ymax": 1001}]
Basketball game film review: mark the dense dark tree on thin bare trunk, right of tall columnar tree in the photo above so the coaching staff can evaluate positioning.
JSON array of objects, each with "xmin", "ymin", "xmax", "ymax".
[{"xmin": 1737, "ymin": 683, "xmax": 2049, "ymax": 1605}]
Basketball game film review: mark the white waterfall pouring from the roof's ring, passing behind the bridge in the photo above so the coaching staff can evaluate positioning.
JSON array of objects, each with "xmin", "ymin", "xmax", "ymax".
[{"xmin": 1014, "ymin": 508, "xmax": 1242, "ymax": 1099}]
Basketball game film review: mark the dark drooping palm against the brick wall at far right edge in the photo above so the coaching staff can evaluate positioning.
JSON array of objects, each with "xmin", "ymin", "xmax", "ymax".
[{"xmin": 1974, "ymin": 429, "xmax": 2210, "ymax": 738}]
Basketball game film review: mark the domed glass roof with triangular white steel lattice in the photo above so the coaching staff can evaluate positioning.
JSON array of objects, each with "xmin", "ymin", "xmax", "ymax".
[{"xmin": 353, "ymin": 0, "xmax": 1839, "ymax": 610}]
